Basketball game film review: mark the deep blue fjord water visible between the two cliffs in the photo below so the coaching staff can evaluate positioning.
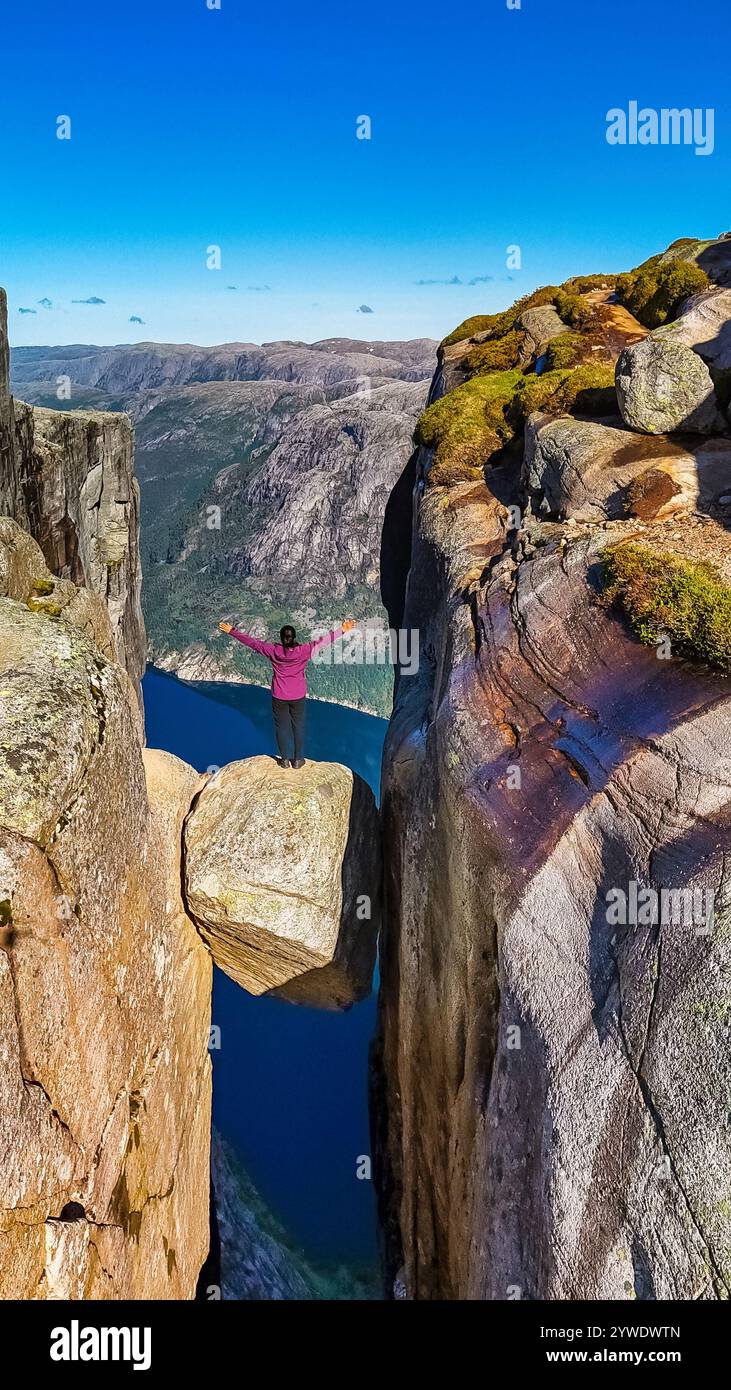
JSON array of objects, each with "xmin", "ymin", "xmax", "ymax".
[{"xmin": 143, "ymin": 669, "xmax": 386, "ymax": 1265}]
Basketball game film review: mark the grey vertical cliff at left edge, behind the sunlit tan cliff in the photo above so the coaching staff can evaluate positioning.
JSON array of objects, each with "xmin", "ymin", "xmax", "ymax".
[{"xmin": 0, "ymin": 293, "xmax": 146, "ymax": 684}]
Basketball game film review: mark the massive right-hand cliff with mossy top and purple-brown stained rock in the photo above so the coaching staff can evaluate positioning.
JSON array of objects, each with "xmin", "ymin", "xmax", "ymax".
[{"xmin": 374, "ymin": 230, "xmax": 731, "ymax": 1300}]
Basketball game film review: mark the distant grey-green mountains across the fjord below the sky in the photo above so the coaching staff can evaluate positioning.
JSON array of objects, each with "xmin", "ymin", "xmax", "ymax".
[{"xmin": 11, "ymin": 338, "xmax": 436, "ymax": 713}]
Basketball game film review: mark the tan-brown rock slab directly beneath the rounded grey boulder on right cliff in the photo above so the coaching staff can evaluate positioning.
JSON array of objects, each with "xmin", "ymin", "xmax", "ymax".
[{"xmin": 523, "ymin": 414, "xmax": 731, "ymax": 523}]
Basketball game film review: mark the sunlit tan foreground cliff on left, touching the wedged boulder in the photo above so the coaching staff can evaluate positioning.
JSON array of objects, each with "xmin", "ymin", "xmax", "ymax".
[{"xmin": 0, "ymin": 592, "xmax": 211, "ymax": 1300}]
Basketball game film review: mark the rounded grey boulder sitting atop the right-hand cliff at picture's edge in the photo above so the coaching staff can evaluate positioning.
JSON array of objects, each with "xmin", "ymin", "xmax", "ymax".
[{"xmin": 616, "ymin": 329, "xmax": 728, "ymax": 434}]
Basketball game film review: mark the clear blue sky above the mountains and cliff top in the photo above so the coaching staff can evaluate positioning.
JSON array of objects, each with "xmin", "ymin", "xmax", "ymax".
[{"xmin": 0, "ymin": 0, "xmax": 731, "ymax": 345}]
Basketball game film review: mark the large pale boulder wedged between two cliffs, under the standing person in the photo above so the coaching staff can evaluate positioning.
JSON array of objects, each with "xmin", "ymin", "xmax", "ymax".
[{"xmin": 185, "ymin": 758, "xmax": 381, "ymax": 1008}]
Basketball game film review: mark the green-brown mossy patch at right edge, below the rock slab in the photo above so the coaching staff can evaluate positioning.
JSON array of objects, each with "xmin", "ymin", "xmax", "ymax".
[{"xmin": 602, "ymin": 541, "xmax": 731, "ymax": 671}]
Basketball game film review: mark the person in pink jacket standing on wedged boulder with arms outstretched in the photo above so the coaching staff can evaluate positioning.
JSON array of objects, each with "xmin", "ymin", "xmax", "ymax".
[{"xmin": 218, "ymin": 619, "xmax": 356, "ymax": 767}]
